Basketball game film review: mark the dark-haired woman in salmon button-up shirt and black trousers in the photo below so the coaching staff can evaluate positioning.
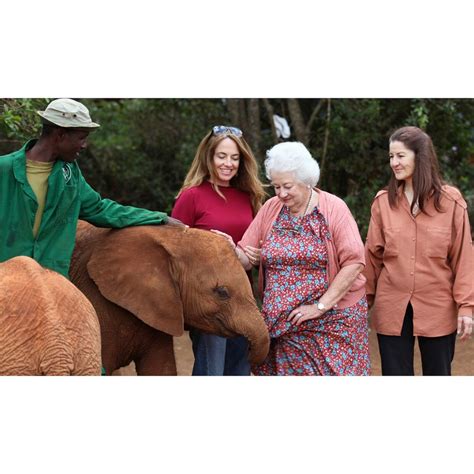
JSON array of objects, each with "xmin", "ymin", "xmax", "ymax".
[{"xmin": 365, "ymin": 127, "xmax": 474, "ymax": 375}]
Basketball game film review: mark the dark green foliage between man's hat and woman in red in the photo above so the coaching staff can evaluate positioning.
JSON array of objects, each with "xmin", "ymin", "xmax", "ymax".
[{"xmin": 81, "ymin": 99, "xmax": 227, "ymax": 212}]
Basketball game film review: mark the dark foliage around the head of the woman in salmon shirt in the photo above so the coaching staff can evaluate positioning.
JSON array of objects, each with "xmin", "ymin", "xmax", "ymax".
[{"xmin": 290, "ymin": 99, "xmax": 474, "ymax": 236}]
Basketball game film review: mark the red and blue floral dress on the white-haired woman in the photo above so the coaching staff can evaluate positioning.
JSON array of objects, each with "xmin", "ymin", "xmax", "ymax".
[{"xmin": 252, "ymin": 206, "xmax": 370, "ymax": 375}]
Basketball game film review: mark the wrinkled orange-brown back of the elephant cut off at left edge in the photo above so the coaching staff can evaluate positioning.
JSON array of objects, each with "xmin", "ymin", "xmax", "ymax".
[{"xmin": 0, "ymin": 257, "xmax": 101, "ymax": 375}]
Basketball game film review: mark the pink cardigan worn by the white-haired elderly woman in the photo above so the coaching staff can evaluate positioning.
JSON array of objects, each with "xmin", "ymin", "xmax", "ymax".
[{"xmin": 238, "ymin": 189, "xmax": 365, "ymax": 309}]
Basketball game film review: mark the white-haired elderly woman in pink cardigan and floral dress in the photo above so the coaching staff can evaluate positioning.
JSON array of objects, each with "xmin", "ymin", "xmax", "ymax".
[{"xmin": 230, "ymin": 142, "xmax": 370, "ymax": 375}]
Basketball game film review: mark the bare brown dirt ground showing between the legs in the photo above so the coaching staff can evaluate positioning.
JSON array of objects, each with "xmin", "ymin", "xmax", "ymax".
[{"xmin": 117, "ymin": 331, "xmax": 474, "ymax": 375}]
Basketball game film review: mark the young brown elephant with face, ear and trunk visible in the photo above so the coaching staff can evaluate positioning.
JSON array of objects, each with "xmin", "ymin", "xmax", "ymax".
[{"xmin": 70, "ymin": 221, "xmax": 269, "ymax": 375}]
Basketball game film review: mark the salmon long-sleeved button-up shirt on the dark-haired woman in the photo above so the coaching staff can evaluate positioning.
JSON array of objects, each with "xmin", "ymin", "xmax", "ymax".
[{"xmin": 364, "ymin": 186, "xmax": 474, "ymax": 337}]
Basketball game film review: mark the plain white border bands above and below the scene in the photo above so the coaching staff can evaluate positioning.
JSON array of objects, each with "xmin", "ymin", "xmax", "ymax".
[{"xmin": 0, "ymin": 0, "xmax": 474, "ymax": 474}]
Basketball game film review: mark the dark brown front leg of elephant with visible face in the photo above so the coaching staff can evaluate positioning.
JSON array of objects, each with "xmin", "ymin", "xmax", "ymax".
[{"xmin": 135, "ymin": 333, "xmax": 177, "ymax": 375}]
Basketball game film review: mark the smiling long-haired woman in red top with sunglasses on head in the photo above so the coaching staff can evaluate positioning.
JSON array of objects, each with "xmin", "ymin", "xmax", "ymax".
[{"xmin": 171, "ymin": 125, "xmax": 265, "ymax": 375}]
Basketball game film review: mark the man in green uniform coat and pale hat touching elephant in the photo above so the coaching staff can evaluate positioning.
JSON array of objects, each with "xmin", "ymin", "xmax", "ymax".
[{"xmin": 0, "ymin": 99, "xmax": 179, "ymax": 277}]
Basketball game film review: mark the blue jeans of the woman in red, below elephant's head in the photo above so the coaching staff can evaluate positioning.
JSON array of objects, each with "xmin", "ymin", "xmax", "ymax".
[{"xmin": 189, "ymin": 329, "xmax": 250, "ymax": 375}]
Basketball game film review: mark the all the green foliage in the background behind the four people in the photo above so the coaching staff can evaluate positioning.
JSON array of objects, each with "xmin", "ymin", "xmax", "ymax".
[{"xmin": 0, "ymin": 99, "xmax": 474, "ymax": 236}]
